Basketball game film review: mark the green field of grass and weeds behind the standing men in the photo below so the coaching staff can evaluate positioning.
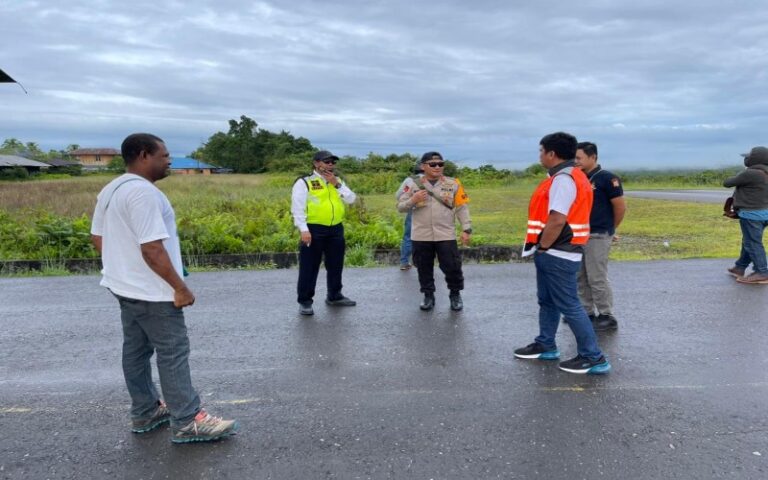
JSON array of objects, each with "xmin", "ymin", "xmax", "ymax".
[{"xmin": 0, "ymin": 174, "xmax": 741, "ymax": 264}]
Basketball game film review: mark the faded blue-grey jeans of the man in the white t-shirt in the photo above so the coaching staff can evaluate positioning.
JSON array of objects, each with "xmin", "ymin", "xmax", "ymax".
[{"xmin": 115, "ymin": 295, "xmax": 200, "ymax": 428}]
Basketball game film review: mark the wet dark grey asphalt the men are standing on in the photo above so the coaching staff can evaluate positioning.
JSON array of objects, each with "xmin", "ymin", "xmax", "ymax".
[{"xmin": 0, "ymin": 260, "xmax": 768, "ymax": 479}]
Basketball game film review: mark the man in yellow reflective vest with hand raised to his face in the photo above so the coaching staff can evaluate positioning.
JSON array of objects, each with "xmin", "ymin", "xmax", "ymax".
[{"xmin": 291, "ymin": 150, "xmax": 357, "ymax": 315}]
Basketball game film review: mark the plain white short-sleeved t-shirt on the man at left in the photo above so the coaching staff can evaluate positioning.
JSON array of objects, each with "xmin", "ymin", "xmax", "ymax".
[{"xmin": 91, "ymin": 173, "xmax": 183, "ymax": 302}]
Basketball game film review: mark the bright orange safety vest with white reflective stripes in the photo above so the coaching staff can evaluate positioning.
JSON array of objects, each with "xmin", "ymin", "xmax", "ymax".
[{"xmin": 525, "ymin": 162, "xmax": 592, "ymax": 252}]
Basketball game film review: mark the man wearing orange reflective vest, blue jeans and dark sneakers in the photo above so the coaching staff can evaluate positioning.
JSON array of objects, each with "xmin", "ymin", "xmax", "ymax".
[{"xmin": 515, "ymin": 132, "xmax": 611, "ymax": 375}]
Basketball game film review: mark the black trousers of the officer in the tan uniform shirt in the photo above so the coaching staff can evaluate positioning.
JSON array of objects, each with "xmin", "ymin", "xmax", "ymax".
[{"xmin": 412, "ymin": 240, "xmax": 464, "ymax": 293}]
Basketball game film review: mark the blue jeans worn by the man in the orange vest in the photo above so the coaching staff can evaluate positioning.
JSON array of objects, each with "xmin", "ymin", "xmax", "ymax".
[{"xmin": 533, "ymin": 253, "xmax": 603, "ymax": 360}]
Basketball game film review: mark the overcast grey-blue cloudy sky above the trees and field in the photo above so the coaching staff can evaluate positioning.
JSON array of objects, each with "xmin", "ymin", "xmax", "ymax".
[{"xmin": 0, "ymin": 0, "xmax": 768, "ymax": 169}]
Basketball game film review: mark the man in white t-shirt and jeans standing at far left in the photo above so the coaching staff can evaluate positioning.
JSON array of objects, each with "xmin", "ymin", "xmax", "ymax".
[{"xmin": 91, "ymin": 133, "xmax": 238, "ymax": 443}]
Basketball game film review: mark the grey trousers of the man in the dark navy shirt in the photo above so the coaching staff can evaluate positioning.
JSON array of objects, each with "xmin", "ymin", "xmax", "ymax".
[{"xmin": 579, "ymin": 233, "xmax": 613, "ymax": 315}]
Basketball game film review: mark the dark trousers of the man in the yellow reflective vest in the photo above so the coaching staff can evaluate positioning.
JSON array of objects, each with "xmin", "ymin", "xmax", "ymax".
[{"xmin": 296, "ymin": 224, "xmax": 346, "ymax": 303}]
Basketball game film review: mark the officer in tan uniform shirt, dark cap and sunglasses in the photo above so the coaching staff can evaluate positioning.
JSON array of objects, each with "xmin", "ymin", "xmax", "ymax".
[{"xmin": 397, "ymin": 152, "xmax": 472, "ymax": 311}]
